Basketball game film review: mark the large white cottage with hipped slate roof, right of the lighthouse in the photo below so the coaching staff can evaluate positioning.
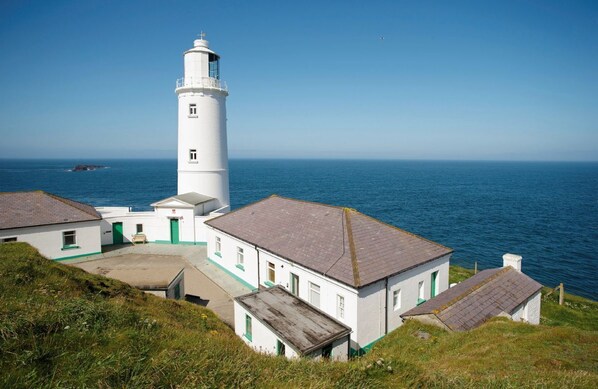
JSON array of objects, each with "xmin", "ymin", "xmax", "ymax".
[{"xmin": 205, "ymin": 196, "xmax": 452, "ymax": 353}]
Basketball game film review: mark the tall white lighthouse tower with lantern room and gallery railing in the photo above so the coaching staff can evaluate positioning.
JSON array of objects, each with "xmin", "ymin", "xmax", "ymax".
[{"xmin": 175, "ymin": 33, "xmax": 230, "ymax": 211}]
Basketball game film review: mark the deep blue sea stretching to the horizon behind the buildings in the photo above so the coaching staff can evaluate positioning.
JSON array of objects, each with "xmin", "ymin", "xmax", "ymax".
[{"xmin": 0, "ymin": 160, "xmax": 598, "ymax": 300}]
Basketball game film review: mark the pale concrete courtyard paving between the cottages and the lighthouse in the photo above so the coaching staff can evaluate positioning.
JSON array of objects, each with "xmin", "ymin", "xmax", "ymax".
[{"xmin": 62, "ymin": 243, "xmax": 251, "ymax": 327}]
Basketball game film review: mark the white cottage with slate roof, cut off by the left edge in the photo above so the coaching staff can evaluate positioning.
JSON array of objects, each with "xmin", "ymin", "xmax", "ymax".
[{"xmin": 0, "ymin": 191, "xmax": 102, "ymax": 260}]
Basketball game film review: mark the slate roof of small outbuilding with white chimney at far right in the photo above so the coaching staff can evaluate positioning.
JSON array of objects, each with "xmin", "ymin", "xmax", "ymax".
[{"xmin": 401, "ymin": 266, "xmax": 542, "ymax": 331}]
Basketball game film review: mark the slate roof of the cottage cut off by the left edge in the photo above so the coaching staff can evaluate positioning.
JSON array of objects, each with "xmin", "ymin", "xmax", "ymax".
[{"xmin": 0, "ymin": 191, "xmax": 102, "ymax": 230}]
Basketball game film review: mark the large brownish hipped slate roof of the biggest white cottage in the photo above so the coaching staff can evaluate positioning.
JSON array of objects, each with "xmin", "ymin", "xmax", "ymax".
[{"xmin": 206, "ymin": 196, "xmax": 453, "ymax": 288}]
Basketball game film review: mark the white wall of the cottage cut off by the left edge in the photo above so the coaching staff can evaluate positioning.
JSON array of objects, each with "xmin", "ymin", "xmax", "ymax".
[{"xmin": 0, "ymin": 220, "xmax": 102, "ymax": 259}]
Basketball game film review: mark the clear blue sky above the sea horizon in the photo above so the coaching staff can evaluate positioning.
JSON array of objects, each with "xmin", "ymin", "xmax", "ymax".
[{"xmin": 0, "ymin": 0, "xmax": 598, "ymax": 161}]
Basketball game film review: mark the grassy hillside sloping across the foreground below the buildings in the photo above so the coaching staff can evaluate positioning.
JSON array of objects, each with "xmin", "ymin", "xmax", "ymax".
[{"xmin": 0, "ymin": 243, "xmax": 598, "ymax": 388}]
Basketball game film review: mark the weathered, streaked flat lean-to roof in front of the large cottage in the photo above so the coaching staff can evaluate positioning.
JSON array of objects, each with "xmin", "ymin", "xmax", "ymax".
[{"xmin": 235, "ymin": 285, "xmax": 351, "ymax": 355}]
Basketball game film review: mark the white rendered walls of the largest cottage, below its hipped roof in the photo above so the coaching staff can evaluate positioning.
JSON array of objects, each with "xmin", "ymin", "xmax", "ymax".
[{"xmin": 206, "ymin": 226, "xmax": 450, "ymax": 351}]
